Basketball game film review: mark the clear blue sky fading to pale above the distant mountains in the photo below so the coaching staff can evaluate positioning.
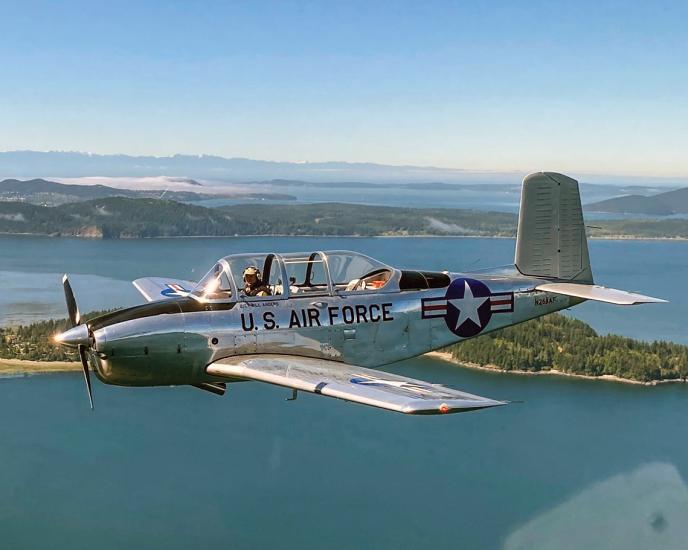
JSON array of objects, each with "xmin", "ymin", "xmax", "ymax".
[{"xmin": 0, "ymin": 0, "xmax": 688, "ymax": 176}]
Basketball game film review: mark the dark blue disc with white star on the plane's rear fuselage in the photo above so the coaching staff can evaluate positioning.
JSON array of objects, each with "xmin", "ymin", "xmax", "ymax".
[{"xmin": 444, "ymin": 278, "xmax": 492, "ymax": 338}]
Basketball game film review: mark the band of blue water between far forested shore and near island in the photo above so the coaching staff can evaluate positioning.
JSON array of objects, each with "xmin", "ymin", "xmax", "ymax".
[{"xmin": 0, "ymin": 236, "xmax": 688, "ymax": 344}]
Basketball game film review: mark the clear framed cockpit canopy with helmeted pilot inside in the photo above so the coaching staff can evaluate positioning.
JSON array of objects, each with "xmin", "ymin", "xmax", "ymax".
[{"xmin": 191, "ymin": 250, "xmax": 449, "ymax": 302}]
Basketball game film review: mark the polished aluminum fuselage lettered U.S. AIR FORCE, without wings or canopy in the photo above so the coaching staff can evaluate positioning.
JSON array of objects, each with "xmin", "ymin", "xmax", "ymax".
[{"xmin": 83, "ymin": 273, "xmax": 580, "ymax": 386}]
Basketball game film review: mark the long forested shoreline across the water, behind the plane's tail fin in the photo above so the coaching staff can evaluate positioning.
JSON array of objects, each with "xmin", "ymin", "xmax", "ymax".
[{"xmin": 0, "ymin": 197, "xmax": 688, "ymax": 239}]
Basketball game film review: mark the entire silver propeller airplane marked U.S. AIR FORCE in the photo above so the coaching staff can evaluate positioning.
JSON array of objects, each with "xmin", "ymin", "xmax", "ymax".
[{"xmin": 55, "ymin": 172, "xmax": 665, "ymax": 415}]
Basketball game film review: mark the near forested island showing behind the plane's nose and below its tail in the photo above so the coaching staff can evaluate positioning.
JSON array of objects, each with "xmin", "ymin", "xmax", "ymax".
[{"xmin": 0, "ymin": 312, "xmax": 688, "ymax": 382}]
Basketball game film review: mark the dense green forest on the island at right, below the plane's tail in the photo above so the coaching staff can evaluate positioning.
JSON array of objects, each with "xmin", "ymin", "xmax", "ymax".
[{"xmin": 448, "ymin": 313, "xmax": 688, "ymax": 382}]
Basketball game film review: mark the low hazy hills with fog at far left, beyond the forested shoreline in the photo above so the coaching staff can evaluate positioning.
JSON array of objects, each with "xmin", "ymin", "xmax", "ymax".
[{"xmin": 0, "ymin": 179, "xmax": 295, "ymax": 206}]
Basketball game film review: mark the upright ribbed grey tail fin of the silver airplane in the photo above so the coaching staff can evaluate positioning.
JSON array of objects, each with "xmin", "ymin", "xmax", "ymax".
[{"xmin": 514, "ymin": 172, "xmax": 593, "ymax": 284}]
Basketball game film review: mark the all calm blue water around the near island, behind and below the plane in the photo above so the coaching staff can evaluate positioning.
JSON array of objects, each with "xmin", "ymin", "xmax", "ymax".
[{"xmin": 0, "ymin": 237, "xmax": 688, "ymax": 549}]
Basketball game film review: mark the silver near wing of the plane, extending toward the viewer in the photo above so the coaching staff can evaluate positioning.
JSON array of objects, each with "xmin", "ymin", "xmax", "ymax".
[{"xmin": 206, "ymin": 355, "xmax": 506, "ymax": 414}]
